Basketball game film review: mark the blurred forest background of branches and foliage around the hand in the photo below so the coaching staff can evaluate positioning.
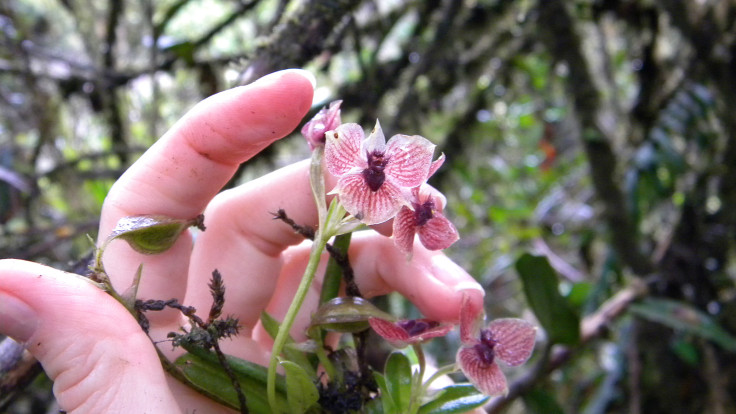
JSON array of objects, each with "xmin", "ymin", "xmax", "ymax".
[{"xmin": 0, "ymin": 0, "xmax": 736, "ymax": 414}]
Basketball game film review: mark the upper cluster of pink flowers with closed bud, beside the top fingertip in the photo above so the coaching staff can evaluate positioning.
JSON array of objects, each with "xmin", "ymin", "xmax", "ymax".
[{"xmin": 302, "ymin": 101, "xmax": 459, "ymax": 254}]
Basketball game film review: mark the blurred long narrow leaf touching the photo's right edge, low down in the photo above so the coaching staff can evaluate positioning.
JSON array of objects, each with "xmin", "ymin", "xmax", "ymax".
[{"xmin": 629, "ymin": 298, "xmax": 736, "ymax": 352}]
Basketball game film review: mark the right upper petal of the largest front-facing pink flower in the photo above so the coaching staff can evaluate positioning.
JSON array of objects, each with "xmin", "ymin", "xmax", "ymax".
[{"xmin": 385, "ymin": 135, "xmax": 435, "ymax": 187}]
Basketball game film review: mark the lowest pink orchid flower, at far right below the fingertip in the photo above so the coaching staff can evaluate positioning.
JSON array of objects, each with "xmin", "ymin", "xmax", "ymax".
[{"xmin": 457, "ymin": 300, "xmax": 536, "ymax": 396}]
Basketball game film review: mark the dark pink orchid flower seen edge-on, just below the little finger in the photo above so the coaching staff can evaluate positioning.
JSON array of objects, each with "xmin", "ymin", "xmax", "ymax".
[{"xmin": 368, "ymin": 318, "xmax": 453, "ymax": 348}]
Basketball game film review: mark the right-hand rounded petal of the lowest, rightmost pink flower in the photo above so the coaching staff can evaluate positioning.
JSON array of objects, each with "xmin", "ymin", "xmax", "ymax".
[{"xmin": 488, "ymin": 318, "xmax": 537, "ymax": 366}]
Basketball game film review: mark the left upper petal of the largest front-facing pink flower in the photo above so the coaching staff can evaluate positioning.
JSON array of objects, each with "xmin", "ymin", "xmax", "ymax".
[{"xmin": 325, "ymin": 123, "xmax": 367, "ymax": 177}]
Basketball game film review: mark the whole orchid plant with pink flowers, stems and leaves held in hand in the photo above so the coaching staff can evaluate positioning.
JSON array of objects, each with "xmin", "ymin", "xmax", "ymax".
[{"xmin": 93, "ymin": 101, "xmax": 536, "ymax": 414}]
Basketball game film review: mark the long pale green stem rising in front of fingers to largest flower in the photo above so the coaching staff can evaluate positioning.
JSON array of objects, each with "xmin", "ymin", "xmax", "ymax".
[{"xmin": 266, "ymin": 229, "xmax": 329, "ymax": 413}]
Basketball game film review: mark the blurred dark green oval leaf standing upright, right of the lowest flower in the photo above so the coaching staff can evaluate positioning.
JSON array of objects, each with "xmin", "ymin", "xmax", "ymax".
[{"xmin": 516, "ymin": 253, "xmax": 580, "ymax": 345}]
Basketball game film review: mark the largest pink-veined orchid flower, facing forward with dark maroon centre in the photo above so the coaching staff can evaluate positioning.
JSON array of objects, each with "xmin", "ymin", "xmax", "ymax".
[{"xmin": 325, "ymin": 122, "xmax": 435, "ymax": 224}]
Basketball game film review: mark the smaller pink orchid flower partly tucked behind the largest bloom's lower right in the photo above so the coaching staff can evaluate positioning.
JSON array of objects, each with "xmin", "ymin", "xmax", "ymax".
[{"xmin": 394, "ymin": 184, "xmax": 460, "ymax": 254}]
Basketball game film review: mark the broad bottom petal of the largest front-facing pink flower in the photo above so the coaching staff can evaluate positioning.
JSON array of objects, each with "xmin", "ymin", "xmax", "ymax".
[{"xmin": 333, "ymin": 173, "xmax": 405, "ymax": 225}]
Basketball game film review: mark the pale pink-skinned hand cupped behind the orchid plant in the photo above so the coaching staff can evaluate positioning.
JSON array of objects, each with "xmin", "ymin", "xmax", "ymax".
[{"xmin": 0, "ymin": 70, "xmax": 483, "ymax": 413}]
